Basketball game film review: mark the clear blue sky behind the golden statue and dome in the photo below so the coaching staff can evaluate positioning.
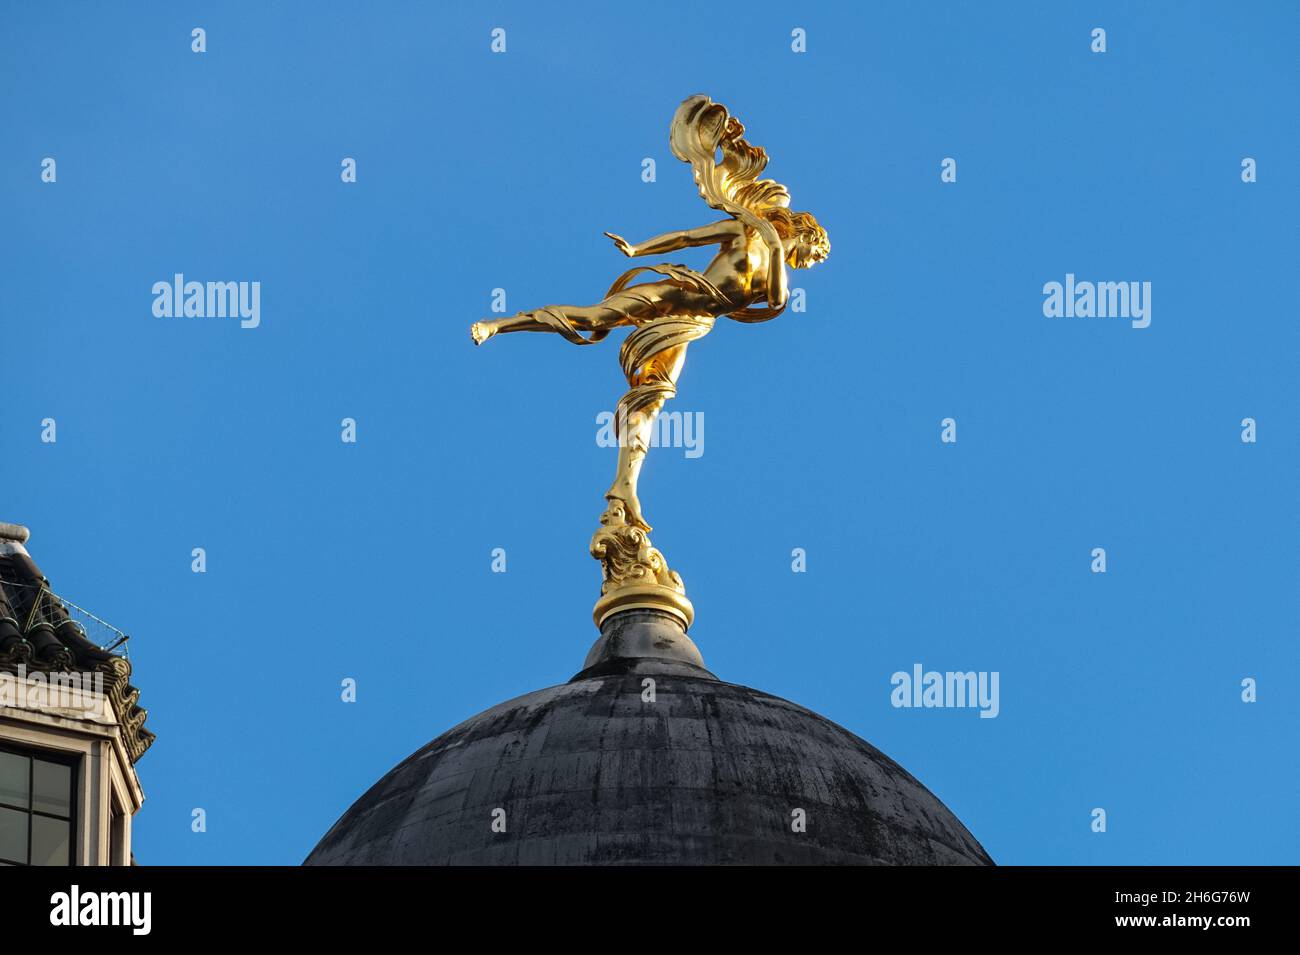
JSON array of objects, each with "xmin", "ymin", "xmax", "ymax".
[{"xmin": 0, "ymin": 3, "xmax": 1300, "ymax": 864}]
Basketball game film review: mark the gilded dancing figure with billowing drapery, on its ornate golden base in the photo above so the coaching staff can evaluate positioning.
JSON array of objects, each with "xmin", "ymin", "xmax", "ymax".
[{"xmin": 469, "ymin": 96, "xmax": 831, "ymax": 626}]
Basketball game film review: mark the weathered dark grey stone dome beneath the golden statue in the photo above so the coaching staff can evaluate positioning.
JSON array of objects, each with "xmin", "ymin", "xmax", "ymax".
[{"xmin": 306, "ymin": 611, "xmax": 993, "ymax": 865}]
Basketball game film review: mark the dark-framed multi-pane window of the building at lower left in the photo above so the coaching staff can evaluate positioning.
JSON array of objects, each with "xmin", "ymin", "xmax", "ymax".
[{"xmin": 0, "ymin": 747, "xmax": 77, "ymax": 865}]
